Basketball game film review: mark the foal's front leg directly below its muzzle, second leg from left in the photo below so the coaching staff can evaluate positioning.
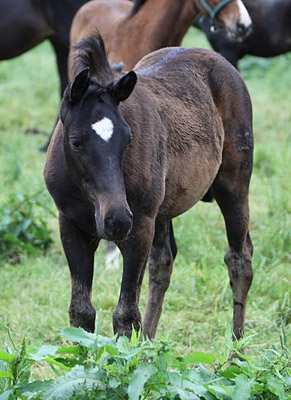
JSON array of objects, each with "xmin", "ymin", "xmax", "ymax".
[{"xmin": 113, "ymin": 214, "xmax": 154, "ymax": 337}]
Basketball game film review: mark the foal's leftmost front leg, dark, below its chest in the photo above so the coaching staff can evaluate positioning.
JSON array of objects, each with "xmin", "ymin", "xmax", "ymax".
[{"xmin": 59, "ymin": 212, "xmax": 99, "ymax": 332}]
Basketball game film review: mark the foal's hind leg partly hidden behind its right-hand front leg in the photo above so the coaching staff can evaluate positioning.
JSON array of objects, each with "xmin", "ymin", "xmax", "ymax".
[{"xmin": 143, "ymin": 221, "xmax": 177, "ymax": 339}]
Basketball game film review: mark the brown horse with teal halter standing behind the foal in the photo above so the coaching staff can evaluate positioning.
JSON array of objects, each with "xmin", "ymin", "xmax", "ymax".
[{"xmin": 69, "ymin": 0, "xmax": 251, "ymax": 74}]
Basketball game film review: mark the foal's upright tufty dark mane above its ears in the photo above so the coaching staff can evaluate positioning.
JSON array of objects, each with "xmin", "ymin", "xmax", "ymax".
[{"xmin": 72, "ymin": 31, "xmax": 114, "ymax": 85}]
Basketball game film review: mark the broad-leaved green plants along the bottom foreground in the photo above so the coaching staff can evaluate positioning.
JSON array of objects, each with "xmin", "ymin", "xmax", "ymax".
[{"xmin": 0, "ymin": 322, "xmax": 291, "ymax": 400}]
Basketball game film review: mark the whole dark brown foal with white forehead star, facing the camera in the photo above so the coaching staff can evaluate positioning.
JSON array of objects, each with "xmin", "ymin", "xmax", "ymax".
[{"xmin": 44, "ymin": 34, "xmax": 253, "ymax": 338}]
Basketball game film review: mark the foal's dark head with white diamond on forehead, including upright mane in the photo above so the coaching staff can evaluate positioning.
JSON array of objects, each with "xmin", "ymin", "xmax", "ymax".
[{"xmin": 60, "ymin": 34, "xmax": 136, "ymax": 241}]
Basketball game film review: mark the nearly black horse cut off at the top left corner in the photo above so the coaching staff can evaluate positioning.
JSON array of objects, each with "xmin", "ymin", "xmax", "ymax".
[{"xmin": 0, "ymin": 0, "xmax": 89, "ymax": 96}]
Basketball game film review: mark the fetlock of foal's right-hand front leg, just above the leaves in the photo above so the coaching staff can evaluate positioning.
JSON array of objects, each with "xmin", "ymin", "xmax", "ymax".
[{"xmin": 113, "ymin": 308, "xmax": 141, "ymax": 339}]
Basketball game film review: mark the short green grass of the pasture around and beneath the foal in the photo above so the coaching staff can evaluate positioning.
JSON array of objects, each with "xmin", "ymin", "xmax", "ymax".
[{"xmin": 0, "ymin": 29, "xmax": 291, "ymax": 362}]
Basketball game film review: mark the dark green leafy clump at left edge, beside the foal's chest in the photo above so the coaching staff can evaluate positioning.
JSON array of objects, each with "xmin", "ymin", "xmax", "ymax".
[{"xmin": 0, "ymin": 193, "xmax": 52, "ymax": 262}]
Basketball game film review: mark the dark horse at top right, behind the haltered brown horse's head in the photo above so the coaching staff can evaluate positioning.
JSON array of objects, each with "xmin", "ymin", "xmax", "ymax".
[{"xmin": 194, "ymin": 0, "xmax": 291, "ymax": 68}]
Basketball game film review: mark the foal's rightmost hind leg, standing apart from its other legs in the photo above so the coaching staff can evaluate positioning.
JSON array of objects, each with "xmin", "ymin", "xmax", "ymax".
[{"xmin": 211, "ymin": 145, "xmax": 253, "ymax": 339}]
